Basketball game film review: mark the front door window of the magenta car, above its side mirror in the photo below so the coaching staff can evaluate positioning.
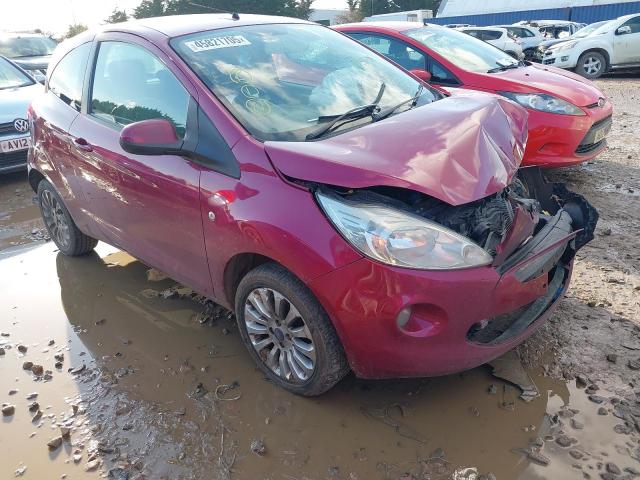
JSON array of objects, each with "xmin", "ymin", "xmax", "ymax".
[{"xmin": 90, "ymin": 42, "xmax": 189, "ymax": 138}]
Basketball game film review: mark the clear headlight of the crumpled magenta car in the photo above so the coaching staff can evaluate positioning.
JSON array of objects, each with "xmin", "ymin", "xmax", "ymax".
[{"xmin": 316, "ymin": 193, "xmax": 493, "ymax": 270}]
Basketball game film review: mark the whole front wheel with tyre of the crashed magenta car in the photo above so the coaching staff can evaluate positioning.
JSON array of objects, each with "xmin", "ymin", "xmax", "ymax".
[{"xmin": 235, "ymin": 263, "xmax": 349, "ymax": 396}]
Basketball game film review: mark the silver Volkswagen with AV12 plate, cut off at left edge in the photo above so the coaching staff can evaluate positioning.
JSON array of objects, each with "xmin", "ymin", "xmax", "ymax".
[{"xmin": 0, "ymin": 55, "xmax": 44, "ymax": 174}]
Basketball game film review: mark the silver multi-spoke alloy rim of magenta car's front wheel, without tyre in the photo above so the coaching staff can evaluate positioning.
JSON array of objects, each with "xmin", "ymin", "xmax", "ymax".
[{"xmin": 244, "ymin": 288, "xmax": 316, "ymax": 383}]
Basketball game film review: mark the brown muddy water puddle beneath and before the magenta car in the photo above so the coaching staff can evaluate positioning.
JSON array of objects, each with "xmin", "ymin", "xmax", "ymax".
[{"xmin": 0, "ymin": 244, "xmax": 638, "ymax": 480}]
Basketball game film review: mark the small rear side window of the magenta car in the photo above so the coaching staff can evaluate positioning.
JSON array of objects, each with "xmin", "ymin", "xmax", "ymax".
[{"xmin": 49, "ymin": 42, "xmax": 91, "ymax": 111}]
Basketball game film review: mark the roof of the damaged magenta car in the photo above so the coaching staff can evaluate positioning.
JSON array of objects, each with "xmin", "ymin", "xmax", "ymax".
[{"xmin": 100, "ymin": 13, "xmax": 312, "ymax": 37}]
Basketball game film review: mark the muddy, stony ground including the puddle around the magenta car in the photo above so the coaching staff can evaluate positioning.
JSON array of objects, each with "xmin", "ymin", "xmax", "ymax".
[{"xmin": 0, "ymin": 77, "xmax": 640, "ymax": 480}]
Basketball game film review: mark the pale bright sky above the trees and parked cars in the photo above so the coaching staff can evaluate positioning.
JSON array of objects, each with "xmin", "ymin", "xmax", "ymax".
[{"xmin": 0, "ymin": 0, "xmax": 346, "ymax": 33}]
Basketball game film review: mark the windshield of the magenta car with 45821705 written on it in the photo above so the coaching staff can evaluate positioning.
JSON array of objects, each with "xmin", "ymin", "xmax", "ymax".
[{"xmin": 171, "ymin": 24, "xmax": 440, "ymax": 141}]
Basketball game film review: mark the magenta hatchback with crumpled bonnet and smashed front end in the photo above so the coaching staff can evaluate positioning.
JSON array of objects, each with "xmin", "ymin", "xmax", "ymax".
[{"xmin": 29, "ymin": 14, "xmax": 597, "ymax": 395}]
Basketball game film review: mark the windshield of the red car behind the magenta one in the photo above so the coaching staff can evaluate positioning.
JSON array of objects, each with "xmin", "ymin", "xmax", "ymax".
[{"xmin": 404, "ymin": 28, "xmax": 518, "ymax": 73}]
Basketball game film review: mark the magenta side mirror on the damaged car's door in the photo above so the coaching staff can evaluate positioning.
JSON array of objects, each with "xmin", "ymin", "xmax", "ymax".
[{"xmin": 120, "ymin": 119, "xmax": 184, "ymax": 155}]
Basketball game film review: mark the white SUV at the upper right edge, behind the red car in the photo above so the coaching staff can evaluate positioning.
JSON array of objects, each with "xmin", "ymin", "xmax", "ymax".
[{"xmin": 542, "ymin": 14, "xmax": 640, "ymax": 79}]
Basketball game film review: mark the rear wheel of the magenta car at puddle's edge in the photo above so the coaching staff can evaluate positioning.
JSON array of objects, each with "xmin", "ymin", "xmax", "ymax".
[{"xmin": 38, "ymin": 180, "xmax": 98, "ymax": 257}]
